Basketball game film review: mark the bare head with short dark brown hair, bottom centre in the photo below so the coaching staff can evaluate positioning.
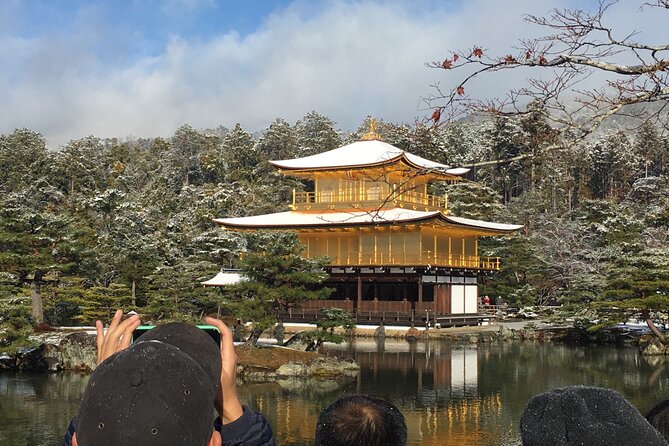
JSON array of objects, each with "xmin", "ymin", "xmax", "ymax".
[{"xmin": 314, "ymin": 395, "xmax": 407, "ymax": 446}]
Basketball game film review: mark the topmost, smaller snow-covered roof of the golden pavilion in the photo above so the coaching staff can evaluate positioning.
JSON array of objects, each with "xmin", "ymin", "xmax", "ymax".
[{"xmin": 270, "ymin": 140, "xmax": 469, "ymax": 176}]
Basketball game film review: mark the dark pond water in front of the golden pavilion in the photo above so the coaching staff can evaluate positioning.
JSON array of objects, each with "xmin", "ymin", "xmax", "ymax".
[{"xmin": 0, "ymin": 339, "xmax": 669, "ymax": 446}]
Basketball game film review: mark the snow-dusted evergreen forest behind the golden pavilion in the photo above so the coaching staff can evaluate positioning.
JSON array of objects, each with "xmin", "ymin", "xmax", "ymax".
[{"xmin": 0, "ymin": 107, "xmax": 669, "ymax": 342}]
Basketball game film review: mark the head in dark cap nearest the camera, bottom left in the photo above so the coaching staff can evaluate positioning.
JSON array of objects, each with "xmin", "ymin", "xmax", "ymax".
[{"xmin": 73, "ymin": 327, "xmax": 221, "ymax": 446}]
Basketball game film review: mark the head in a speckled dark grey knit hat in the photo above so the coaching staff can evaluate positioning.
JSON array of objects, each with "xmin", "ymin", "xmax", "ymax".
[{"xmin": 520, "ymin": 386, "xmax": 666, "ymax": 446}]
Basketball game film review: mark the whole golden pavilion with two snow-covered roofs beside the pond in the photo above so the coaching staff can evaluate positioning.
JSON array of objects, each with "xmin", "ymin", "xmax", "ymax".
[{"xmin": 215, "ymin": 128, "xmax": 522, "ymax": 324}]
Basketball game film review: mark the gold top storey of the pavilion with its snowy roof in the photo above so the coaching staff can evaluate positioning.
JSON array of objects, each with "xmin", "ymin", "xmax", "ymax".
[{"xmin": 271, "ymin": 134, "xmax": 468, "ymax": 213}]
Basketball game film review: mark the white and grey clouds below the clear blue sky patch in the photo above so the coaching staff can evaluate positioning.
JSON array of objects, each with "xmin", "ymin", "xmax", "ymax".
[{"xmin": 0, "ymin": 0, "xmax": 656, "ymax": 146}]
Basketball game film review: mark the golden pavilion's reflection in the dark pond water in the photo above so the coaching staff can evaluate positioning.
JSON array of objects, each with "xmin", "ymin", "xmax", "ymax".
[{"xmin": 237, "ymin": 340, "xmax": 503, "ymax": 446}]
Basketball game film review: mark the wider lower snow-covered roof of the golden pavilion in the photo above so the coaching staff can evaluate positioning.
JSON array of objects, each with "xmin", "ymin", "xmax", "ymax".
[{"xmin": 214, "ymin": 208, "xmax": 523, "ymax": 233}]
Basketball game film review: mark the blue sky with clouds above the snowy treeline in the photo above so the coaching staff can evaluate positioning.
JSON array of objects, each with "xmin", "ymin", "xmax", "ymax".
[{"xmin": 0, "ymin": 0, "xmax": 669, "ymax": 148}]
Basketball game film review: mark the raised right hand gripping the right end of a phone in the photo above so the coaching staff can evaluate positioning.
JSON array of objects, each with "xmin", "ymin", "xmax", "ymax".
[{"xmin": 204, "ymin": 317, "xmax": 244, "ymax": 424}]
